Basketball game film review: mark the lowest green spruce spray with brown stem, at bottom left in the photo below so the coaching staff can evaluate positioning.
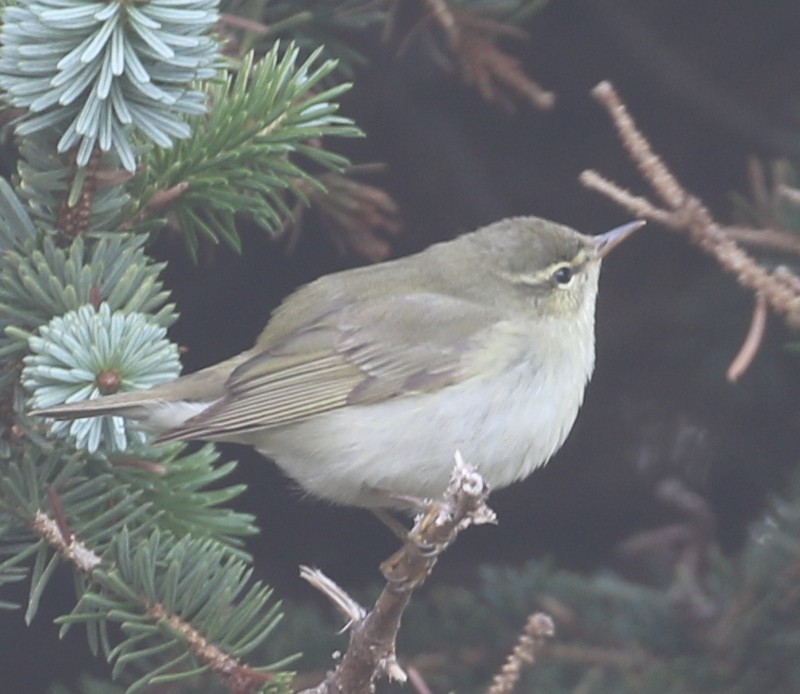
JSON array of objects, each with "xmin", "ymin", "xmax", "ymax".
[{"xmin": 59, "ymin": 530, "xmax": 294, "ymax": 694}]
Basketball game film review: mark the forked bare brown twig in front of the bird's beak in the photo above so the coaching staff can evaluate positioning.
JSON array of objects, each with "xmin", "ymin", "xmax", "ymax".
[{"xmin": 581, "ymin": 82, "xmax": 800, "ymax": 328}]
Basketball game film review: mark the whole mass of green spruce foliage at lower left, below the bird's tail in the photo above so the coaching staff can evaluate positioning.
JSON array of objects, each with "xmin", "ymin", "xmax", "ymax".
[{"xmin": 0, "ymin": 430, "xmax": 283, "ymax": 691}]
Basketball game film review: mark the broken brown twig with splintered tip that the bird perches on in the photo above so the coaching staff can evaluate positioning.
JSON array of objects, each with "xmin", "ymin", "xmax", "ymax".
[{"xmin": 304, "ymin": 454, "xmax": 495, "ymax": 694}]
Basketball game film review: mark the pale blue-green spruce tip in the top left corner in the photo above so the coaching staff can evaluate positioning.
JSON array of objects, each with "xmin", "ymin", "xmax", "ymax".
[{"xmin": 0, "ymin": 0, "xmax": 218, "ymax": 171}]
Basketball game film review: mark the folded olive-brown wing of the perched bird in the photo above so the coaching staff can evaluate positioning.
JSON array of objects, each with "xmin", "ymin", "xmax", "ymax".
[{"xmin": 161, "ymin": 293, "xmax": 492, "ymax": 440}]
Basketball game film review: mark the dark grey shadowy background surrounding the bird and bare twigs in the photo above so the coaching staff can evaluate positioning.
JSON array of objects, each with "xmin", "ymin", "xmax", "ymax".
[{"xmin": 0, "ymin": 0, "xmax": 800, "ymax": 692}]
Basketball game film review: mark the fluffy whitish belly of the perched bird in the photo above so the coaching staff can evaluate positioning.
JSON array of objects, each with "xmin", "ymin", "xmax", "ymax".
[{"xmin": 251, "ymin": 363, "xmax": 587, "ymax": 506}]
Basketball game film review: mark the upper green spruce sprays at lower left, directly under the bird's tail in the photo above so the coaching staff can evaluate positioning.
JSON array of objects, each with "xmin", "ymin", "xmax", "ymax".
[{"xmin": 0, "ymin": 429, "xmax": 255, "ymax": 632}]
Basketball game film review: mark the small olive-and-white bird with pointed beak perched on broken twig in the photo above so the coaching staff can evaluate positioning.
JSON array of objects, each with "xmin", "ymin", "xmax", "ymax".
[{"xmin": 31, "ymin": 217, "xmax": 643, "ymax": 507}]
